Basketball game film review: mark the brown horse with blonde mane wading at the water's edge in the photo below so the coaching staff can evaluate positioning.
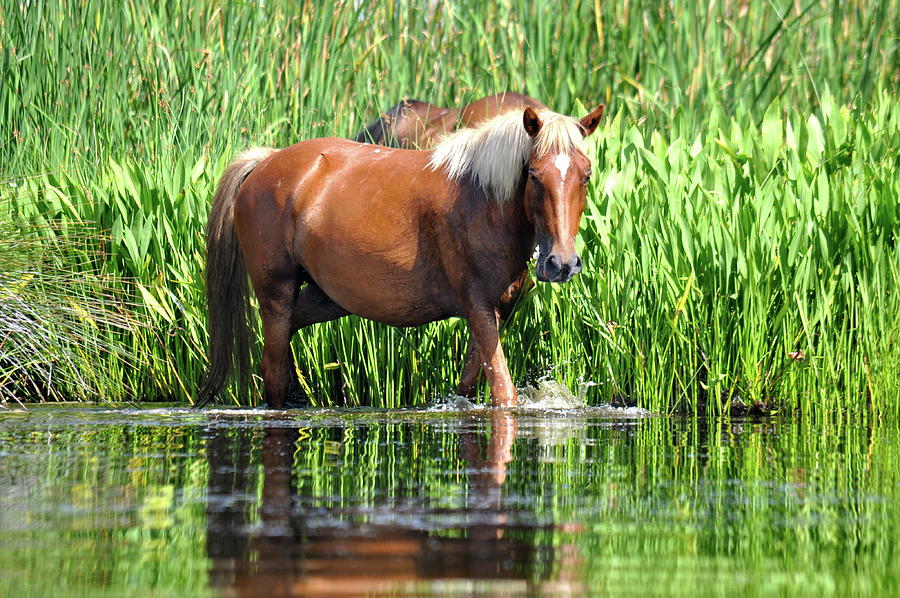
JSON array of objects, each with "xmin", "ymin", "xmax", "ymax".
[{"xmin": 198, "ymin": 105, "xmax": 603, "ymax": 408}]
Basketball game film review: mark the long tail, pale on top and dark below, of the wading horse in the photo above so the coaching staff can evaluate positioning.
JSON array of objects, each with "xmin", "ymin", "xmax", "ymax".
[{"xmin": 195, "ymin": 147, "xmax": 276, "ymax": 407}]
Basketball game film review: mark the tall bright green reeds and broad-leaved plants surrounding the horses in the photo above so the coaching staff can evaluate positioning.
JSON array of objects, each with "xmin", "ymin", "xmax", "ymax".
[{"xmin": 0, "ymin": 0, "xmax": 900, "ymax": 413}]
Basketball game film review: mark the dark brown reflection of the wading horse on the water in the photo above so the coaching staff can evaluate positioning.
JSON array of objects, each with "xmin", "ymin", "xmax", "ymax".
[{"xmin": 207, "ymin": 411, "xmax": 583, "ymax": 598}]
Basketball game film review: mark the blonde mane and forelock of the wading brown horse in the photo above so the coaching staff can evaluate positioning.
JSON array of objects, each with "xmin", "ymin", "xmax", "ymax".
[{"xmin": 428, "ymin": 110, "xmax": 585, "ymax": 203}]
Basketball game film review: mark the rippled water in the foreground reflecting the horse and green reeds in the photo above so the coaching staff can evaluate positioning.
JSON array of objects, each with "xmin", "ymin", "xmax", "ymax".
[{"xmin": 0, "ymin": 398, "xmax": 900, "ymax": 598}]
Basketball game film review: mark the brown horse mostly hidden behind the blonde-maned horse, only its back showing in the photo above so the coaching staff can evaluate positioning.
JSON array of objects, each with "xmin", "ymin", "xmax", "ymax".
[{"xmin": 356, "ymin": 91, "xmax": 547, "ymax": 149}]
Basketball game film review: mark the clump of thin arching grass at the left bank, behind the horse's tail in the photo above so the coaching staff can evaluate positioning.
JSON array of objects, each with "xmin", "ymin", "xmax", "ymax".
[{"xmin": 0, "ymin": 218, "xmax": 139, "ymax": 404}]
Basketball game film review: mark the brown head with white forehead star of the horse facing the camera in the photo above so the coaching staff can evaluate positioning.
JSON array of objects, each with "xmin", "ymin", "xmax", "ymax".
[{"xmin": 522, "ymin": 104, "xmax": 603, "ymax": 282}]
